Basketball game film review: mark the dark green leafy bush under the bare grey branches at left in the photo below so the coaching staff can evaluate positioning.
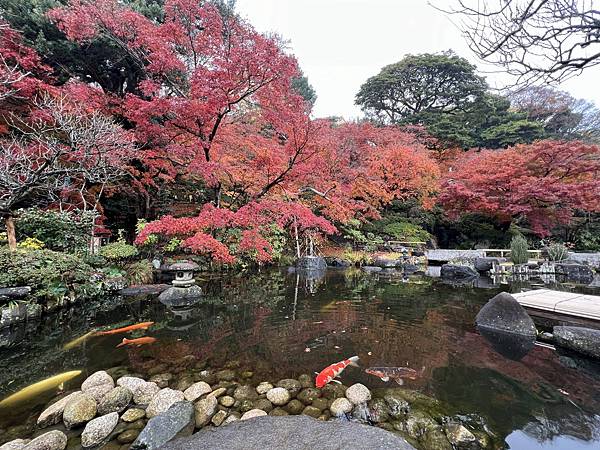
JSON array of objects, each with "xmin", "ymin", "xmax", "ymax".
[{"xmin": 15, "ymin": 208, "xmax": 94, "ymax": 252}]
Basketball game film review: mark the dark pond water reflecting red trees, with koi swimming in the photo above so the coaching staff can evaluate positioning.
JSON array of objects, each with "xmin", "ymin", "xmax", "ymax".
[{"xmin": 0, "ymin": 269, "xmax": 600, "ymax": 450}]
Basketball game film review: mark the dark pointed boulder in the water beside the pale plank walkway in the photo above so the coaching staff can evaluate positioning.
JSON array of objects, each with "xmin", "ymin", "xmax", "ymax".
[{"xmin": 475, "ymin": 292, "xmax": 537, "ymax": 337}]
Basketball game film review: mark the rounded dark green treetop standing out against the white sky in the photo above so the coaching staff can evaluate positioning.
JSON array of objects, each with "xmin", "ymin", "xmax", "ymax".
[{"xmin": 356, "ymin": 52, "xmax": 487, "ymax": 124}]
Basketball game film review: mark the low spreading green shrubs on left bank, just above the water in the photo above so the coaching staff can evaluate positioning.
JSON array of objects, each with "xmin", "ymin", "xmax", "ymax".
[{"xmin": 0, "ymin": 248, "xmax": 100, "ymax": 300}]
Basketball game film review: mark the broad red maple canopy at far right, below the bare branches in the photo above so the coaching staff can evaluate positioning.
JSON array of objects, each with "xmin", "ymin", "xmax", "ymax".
[{"xmin": 439, "ymin": 141, "xmax": 600, "ymax": 236}]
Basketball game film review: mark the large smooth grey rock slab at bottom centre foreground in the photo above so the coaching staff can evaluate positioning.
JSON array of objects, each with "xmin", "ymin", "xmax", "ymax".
[{"xmin": 163, "ymin": 415, "xmax": 414, "ymax": 450}]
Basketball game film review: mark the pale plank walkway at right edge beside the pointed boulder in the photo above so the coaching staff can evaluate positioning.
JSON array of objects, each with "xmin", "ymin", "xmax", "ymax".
[{"xmin": 512, "ymin": 289, "xmax": 600, "ymax": 321}]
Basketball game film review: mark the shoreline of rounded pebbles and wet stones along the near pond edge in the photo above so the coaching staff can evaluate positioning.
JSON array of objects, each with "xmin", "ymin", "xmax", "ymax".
[{"xmin": 0, "ymin": 360, "xmax": 501, "ymax": 450}]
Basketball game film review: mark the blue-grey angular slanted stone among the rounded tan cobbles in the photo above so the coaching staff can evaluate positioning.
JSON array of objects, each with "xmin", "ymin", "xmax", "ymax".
[{"xmin": 131, "ymin": 401, "xmax": 194, "ymax": 450}]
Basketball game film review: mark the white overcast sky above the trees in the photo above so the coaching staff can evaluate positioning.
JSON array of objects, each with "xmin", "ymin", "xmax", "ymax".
[{"xmin": 237, "ymin": 0, "xmax": 600, "ymax": 118}]
